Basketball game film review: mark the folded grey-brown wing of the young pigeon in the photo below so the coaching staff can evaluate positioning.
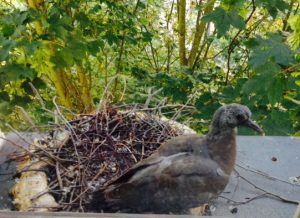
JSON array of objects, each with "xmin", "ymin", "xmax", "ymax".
[{"xmin": 105, "ymin": 152, "xmax": 228, "ymax": 206}]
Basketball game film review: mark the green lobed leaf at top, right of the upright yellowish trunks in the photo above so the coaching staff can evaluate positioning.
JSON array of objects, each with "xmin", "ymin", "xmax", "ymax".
[{"xmin": 202, "ymin": 7, "xmax": 245, "ymax": 37}]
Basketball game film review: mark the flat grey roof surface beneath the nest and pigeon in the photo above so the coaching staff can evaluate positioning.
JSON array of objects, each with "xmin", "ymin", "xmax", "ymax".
[{"xmin": 0, "ymin": 136, "xmax": 300, "ymax": 218}]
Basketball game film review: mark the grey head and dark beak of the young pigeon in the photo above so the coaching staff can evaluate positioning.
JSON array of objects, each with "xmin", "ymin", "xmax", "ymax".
[{"xmin": 212, "ymin": 104, "xmax": 264, "ymax": 134}]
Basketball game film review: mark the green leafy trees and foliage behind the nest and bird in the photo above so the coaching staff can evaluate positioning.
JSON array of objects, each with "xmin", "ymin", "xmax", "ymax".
[{"xmin": 0, "ymin": 0, "xmax": 300, "ymax": 135}]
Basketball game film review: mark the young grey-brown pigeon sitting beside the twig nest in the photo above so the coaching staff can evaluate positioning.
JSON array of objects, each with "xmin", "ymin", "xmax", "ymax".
[{"xmin": 89, "ymin": 104, "xmax": 263, "ymax": 214}]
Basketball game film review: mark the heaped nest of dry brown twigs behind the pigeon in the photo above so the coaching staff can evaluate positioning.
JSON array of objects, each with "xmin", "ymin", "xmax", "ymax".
[{"xmin": 16, "ymin": 108, "xmax": 188, "ymax": 212}]
